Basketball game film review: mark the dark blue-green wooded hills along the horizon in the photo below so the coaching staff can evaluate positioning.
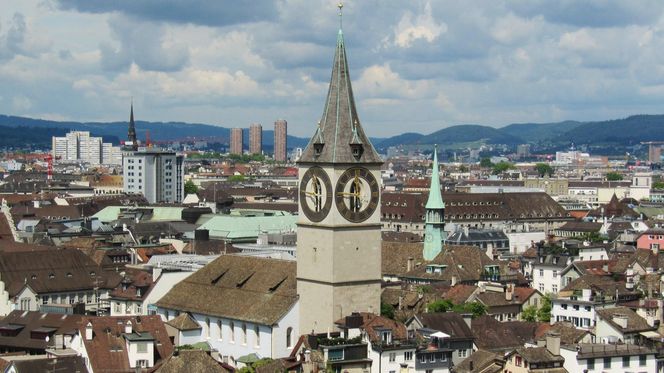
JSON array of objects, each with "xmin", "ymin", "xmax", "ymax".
[{"xmin": 0, "ymin": 115, "xmax": 664, "ymax": 151}]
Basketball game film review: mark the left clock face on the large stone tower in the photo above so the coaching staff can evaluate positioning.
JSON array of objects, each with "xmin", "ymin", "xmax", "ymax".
[{"xmin": 300, "ymin": 167, "xmax": 332, "ymax": 222}]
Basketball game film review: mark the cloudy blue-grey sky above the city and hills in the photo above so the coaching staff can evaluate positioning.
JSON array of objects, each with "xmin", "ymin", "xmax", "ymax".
[{"xmin": 0, "ymin": 0, "xmax": 664, "ymax": 136}]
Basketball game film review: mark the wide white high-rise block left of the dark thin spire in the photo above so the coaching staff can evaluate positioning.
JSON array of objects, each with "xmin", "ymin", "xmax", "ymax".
[{"xmin": 51, "ymin": 131, "xmax": 122, "ymax": 165}]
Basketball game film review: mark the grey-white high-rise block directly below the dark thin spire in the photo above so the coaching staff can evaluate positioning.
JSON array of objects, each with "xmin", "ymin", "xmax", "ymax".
[{"xmin": 122, "ymin": 149, "xmax": 184, "ymax": 203}]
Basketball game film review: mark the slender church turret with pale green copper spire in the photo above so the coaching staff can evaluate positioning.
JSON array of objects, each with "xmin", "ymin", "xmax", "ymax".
[{"xmin": 424, "ymin": 145, "xmax": 447, "ymax": 260}]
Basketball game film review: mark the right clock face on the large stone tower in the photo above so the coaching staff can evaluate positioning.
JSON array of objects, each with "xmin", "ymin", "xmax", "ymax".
[{"xmin": 334, "ymin": 167, "xmax": 380, "ymax": 223}]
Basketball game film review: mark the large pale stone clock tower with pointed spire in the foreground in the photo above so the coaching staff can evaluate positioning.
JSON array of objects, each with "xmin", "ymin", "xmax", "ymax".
[{"xmin": 297, "ymin": 5, "xmax": 383, "ymax": 333}]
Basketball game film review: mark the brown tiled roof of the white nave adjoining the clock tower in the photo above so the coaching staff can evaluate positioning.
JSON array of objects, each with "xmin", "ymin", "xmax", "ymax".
[{"xmin": 157, "ymin": 255, "xmax": 297, "ymax": 326}]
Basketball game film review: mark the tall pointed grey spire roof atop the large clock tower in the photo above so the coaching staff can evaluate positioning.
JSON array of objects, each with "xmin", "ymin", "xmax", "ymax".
[{"xmin": 299, "ymin": 29, "xmax": 383, "ymax": 164}]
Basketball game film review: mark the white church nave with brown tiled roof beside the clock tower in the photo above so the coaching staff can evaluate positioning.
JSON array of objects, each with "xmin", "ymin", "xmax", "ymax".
[{"xmin": 156, "ymin": 255, "xmax": 299, "ymax": 365}]
